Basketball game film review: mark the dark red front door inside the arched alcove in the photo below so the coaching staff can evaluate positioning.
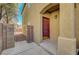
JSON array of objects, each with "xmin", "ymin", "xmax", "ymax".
[{"xmin": 42, "ymin": 17, "xmax": 50, "ymax": 39}]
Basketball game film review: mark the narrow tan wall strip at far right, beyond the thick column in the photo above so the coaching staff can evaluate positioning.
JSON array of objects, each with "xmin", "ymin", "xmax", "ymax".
[{"xmin": 75, "ymin": 3, "xmax": 79, "ymax": 48}]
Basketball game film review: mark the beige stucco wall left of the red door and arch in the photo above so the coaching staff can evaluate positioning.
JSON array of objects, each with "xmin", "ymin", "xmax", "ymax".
[{"xmin": 28, "ymin": 3, "xmax": 48, "ymax": 43}]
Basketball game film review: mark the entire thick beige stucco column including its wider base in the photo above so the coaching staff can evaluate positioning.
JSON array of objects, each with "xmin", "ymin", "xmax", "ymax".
[{"xmin": 57, "ymin": 3, "xmax": 76, "ymax": 55}]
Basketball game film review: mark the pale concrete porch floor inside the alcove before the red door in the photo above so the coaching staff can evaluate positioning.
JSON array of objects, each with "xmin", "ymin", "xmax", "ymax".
[{"xmin": 40, "ymin": 39, "xmax": 57, "ymax": 55}]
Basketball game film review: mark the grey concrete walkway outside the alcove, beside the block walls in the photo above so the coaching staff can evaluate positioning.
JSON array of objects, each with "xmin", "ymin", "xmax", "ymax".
[{"xmin": 2, "ymin": 41, "xmax": 49, "ymax": 55}]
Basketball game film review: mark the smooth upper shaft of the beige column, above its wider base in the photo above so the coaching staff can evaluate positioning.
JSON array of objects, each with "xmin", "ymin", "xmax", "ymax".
[{"xmin": 60, "ymin": 3, "xmax": 75, "ymax": 38}]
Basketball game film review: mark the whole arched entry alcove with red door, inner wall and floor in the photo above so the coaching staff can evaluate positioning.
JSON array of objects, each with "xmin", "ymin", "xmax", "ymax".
[{"xmin": 40, "ymin": 3, "xmax": 59, "ymax": 54}]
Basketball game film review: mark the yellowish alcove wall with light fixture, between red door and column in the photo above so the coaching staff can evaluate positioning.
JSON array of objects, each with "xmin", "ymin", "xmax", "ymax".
[{"xmin": 50, "ymin": 11, "xmax": 59, "ymax": 43}]
